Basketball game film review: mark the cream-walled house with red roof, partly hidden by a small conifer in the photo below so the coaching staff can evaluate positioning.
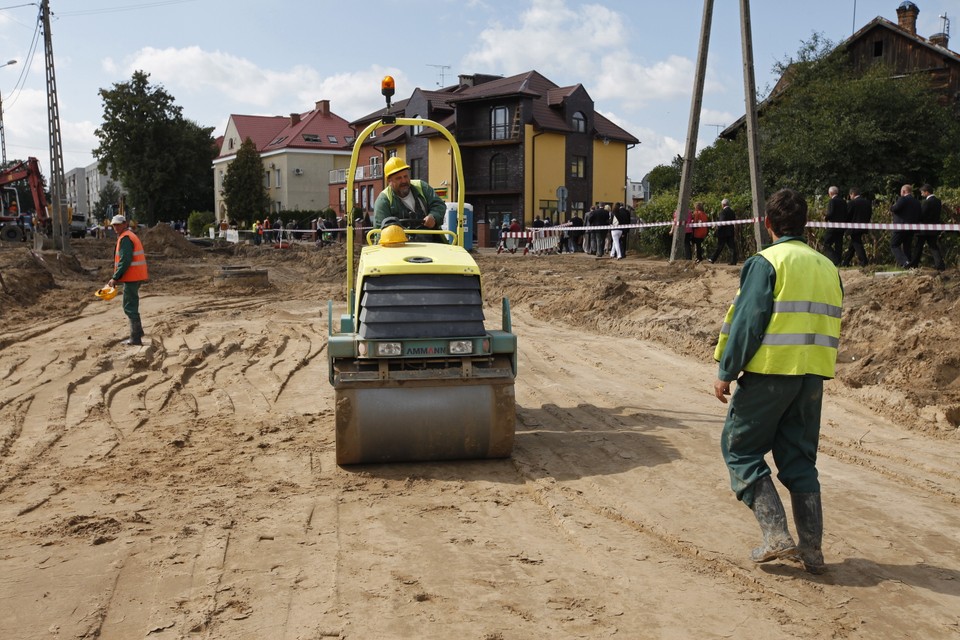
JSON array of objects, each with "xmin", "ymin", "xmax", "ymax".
[{"xmin": 213, "ymin": 100, "xmax": 354, "ymax": 222}]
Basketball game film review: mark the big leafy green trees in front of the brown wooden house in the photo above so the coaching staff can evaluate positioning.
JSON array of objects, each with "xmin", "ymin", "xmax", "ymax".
[{"xmin": 694, "ymin": 34, "xmax": 960, "ymax": 195}]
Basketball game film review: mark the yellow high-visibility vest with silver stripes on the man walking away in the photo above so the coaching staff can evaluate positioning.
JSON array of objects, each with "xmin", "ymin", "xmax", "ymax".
[{"xmin": 714, "ymin": 241, "xmax": 843, "ymax": 378}]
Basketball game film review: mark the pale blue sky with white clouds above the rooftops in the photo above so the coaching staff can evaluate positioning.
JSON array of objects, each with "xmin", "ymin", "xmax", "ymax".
[{"xmin": 0, "ymin": 0, "xmax": 960, "ymax": 185}]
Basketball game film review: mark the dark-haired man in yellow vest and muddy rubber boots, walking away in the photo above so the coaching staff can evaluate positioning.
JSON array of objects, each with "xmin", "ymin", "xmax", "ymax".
[{"xmin": 713, "ymin": 189, "xmax": 843, "ymax": 573}]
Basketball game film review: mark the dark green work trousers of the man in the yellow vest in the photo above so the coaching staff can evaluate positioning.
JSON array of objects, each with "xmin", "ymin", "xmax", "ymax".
[{"xmin": 720, "ymin": 372, "xmax": 823, "ymax": 508}]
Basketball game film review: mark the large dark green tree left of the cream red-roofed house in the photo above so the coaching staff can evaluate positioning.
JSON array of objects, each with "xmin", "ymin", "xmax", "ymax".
[{"xmin": 93, "ymin": 71, "xmax": 215, "ymax": 224}]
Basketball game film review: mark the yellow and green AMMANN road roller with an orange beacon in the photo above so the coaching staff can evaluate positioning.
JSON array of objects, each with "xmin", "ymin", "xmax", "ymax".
[{"xmin": 327, "ymin": 76, "xmax": 517, "ymax": 465}]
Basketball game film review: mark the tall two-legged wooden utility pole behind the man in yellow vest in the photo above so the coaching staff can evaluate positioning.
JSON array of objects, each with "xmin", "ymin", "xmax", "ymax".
[{"xmin": 670, "ymin": 0, "xmax": 770, "ymax": 262}]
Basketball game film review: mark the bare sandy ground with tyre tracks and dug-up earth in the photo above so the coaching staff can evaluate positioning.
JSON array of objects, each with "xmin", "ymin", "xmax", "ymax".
[{"xmin": 0, "ymin": 231, "xmax": 960, "ymax": 640}]
